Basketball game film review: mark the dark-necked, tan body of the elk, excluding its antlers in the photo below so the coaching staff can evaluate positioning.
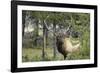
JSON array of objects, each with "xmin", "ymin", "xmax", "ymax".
[{"xmin": 56, "ymin": 34, "xmax": 80, "ymax": 60}]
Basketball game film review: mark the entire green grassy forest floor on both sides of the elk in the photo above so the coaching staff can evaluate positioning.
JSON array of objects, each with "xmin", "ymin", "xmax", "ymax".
[{"xmin": 22, "ymin": 48, "xmax": 89, "ymax": 62}]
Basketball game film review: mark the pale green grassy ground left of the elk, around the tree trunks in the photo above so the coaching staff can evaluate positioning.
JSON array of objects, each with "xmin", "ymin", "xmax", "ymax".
[{"xmin": 22, "ymin": 48, "xmax": 63, "ymax": 62}]
